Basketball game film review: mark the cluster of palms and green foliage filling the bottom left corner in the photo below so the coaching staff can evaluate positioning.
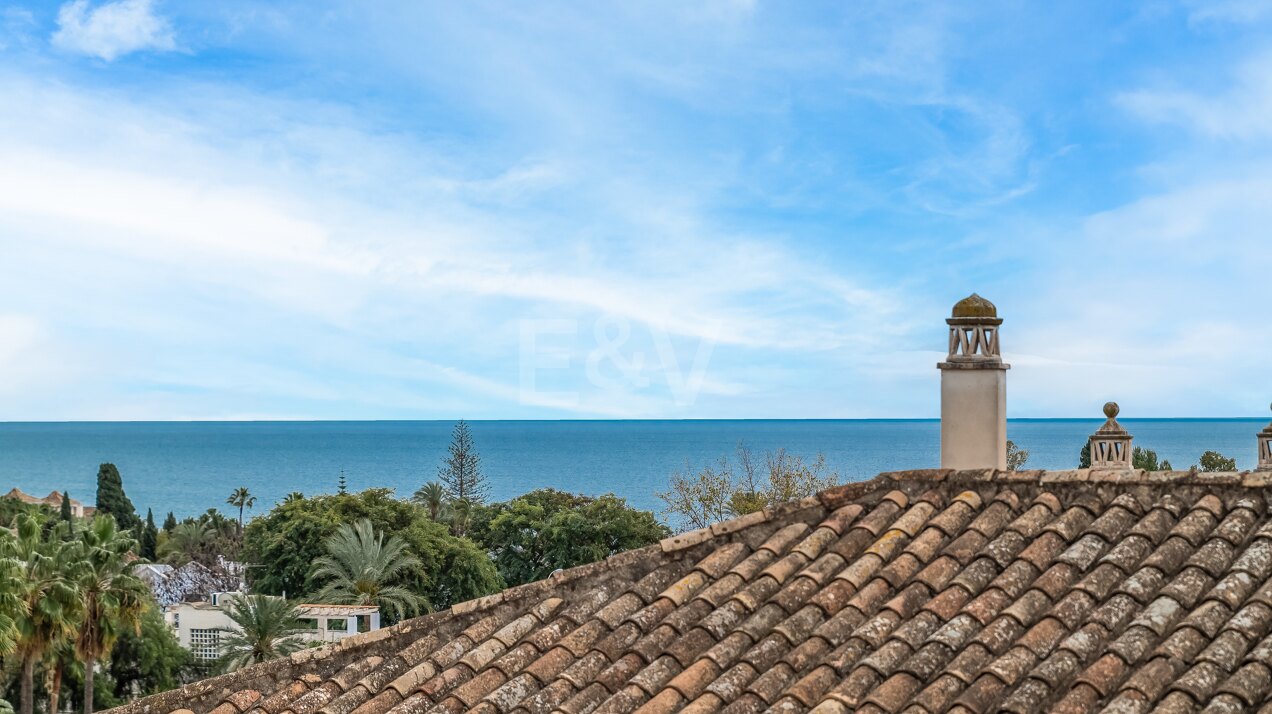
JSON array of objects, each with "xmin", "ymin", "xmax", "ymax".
[{"xmin": 0, "ymin": 499, "xmax": 188, "ymax": 713}]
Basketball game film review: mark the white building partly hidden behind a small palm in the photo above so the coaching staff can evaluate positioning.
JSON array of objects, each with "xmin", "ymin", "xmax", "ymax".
[{"xmin": 164, "ymin": 592, "xmax": 380, "ymax": 662}]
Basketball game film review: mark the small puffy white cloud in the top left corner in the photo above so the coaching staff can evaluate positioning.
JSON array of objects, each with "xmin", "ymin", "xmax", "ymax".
[{"xmin": 52, "ymin": 0, "xmax": 177, "ymax": 61}]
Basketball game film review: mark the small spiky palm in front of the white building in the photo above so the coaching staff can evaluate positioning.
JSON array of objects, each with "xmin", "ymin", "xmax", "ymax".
[{"xmin": 219, "ymin": 594, "xmax": 307, "ymax": 672}]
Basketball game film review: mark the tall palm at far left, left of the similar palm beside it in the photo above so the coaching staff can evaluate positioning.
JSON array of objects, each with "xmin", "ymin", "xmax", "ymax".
[{"xmin": 6, "ymin": 514, "xmax": 83, "ymax": 714}]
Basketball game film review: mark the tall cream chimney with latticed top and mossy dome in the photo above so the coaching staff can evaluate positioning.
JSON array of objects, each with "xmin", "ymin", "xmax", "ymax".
[{"xmin": 936, "ymin": 293, "xmax": 1011, "ymax": 470}]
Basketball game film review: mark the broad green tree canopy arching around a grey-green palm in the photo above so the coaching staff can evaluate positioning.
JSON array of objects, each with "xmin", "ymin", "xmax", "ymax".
[{"xmin": 243, "ymin": 489, "xmax": 502, "ymax": 607}]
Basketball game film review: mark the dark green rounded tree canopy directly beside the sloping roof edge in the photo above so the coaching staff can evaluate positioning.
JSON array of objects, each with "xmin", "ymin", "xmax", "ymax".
[{"xmin": 473, "ymin": 489, "xmax": 670, "ymax": 585}]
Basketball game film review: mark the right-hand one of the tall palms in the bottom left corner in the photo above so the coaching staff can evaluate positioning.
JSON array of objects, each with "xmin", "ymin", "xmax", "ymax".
[{"xmin": 75, "ymin": 515, "xmax": 149, "ymax": 714}]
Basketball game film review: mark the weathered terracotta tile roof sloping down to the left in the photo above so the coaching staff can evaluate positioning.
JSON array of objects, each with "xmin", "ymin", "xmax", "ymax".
[{"xmin": 106, "ymin": 471, "xmax": 1272, "ymax": 714}]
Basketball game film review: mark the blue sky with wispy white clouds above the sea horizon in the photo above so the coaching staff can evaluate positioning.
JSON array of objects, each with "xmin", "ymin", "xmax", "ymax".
[{"xmin": 0, "ymin": 0, "xmax": 1272, "ymax": 421}]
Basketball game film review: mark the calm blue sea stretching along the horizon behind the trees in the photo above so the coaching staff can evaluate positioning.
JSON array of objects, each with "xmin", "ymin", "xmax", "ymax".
[{"xmin": 0, "ymin": 419, "xmax": 1266, "ymax": 518}]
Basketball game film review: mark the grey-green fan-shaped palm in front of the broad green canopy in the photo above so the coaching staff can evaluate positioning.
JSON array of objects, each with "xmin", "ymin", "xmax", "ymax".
[{"xmin": 313, "ymin": 518, "xmax": 424, "ymax": 617}]
